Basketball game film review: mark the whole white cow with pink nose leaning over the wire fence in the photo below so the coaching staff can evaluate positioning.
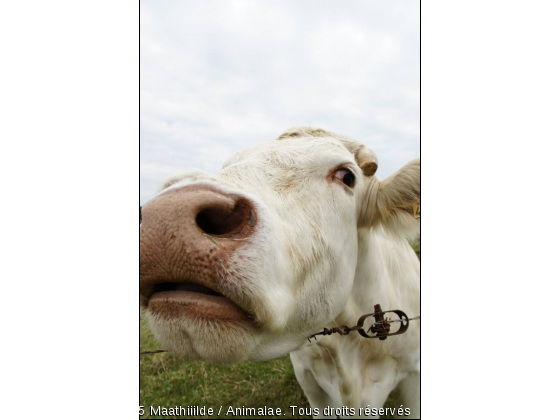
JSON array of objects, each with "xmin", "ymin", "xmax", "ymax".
[{"xmin": 140, "ymin": 127, "xmax": 420, "ymax": 418}]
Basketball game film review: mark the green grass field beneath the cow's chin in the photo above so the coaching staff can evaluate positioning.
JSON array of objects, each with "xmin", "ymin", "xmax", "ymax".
[{"xmin": 140, "ymin": 243, "xmax": 420, "ymax": 419}]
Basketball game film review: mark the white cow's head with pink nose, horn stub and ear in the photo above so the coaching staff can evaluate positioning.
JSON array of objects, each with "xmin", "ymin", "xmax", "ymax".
[{"xmin": 140, "ymin": 128, "xmax": 420, "ymax": 363}]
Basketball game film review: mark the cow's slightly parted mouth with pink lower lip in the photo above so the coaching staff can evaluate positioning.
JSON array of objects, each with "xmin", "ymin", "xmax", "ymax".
[{"xmin": 147, "ymin": 282, "xmax": 250, "ymax": 321}]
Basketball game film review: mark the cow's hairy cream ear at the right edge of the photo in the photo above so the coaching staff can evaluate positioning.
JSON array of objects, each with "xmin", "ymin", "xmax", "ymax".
[{"xmin": 360, "ymin": 159, "xmax": 420, "ymax": 239}]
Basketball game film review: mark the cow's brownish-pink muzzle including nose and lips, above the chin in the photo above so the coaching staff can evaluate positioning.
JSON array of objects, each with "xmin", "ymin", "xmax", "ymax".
[{"xmin": 140, "ymin": 185, "xmax": 257, "ymax": 321}]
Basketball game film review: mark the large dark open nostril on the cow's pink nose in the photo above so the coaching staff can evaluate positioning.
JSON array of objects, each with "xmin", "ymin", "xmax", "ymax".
[{"xmin": 196, "ymin": 202, "xmax": 254, "ymax": 236}]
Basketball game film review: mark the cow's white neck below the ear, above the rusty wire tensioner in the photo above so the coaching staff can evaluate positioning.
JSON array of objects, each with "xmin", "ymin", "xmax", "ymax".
[{"xmin": 337, "ymin": 229, "xmax": 420, "ymax": 326}]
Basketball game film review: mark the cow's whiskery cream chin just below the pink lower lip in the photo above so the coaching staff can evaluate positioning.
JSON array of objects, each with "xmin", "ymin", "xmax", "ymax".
[{"xmin": 144, "ymin": 310, "xmax": 260, "ymax": 364}]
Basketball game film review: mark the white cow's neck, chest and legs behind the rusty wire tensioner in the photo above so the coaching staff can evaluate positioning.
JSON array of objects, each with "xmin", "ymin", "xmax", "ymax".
[{"xmin": 290, "ymin": 229, "xmax": 420, "ymax": 418}]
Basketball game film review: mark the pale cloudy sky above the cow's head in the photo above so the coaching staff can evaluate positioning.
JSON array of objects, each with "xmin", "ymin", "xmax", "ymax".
[{"xmin": 140, "ymin": 0, "xmax": 420, "ymax": 204}]
